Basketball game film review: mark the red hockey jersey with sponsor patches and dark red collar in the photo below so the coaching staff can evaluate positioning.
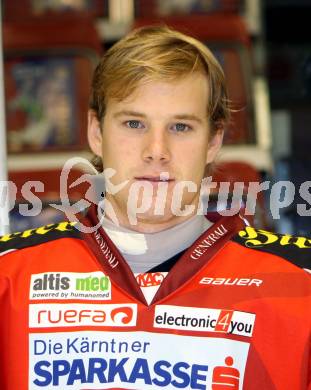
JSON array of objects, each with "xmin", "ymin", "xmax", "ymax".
[{"xmin": 0, "ymin": 210, "xmax": 311, "ymax": 390}]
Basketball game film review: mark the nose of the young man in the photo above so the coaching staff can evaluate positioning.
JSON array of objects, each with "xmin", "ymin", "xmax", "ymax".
[{"xmin": 142, "ymin": 128, "xmax": 171, "ymax": 163}]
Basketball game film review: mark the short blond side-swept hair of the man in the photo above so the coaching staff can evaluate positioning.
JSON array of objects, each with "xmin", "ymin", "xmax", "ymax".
[{"xmin": 89, "ymin": 26, "xmax": 230, "ymax": 170}]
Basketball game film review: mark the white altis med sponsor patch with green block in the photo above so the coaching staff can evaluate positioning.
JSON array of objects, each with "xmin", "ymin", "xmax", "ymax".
[{"xmin": 29, "ymin": 271, "xmax": 111, "ymax": 300}]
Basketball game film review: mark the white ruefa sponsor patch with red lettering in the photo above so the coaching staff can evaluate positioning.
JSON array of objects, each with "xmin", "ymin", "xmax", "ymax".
[{"xmin": 29, "ymin": 303, "xmax": 137, "ymax": 328}]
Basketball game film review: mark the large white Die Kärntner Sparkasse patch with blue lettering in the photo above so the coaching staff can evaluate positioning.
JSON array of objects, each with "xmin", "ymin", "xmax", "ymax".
[{"xmin": 29, "ymin": 331, "xmax": 249, "ymax": 390}]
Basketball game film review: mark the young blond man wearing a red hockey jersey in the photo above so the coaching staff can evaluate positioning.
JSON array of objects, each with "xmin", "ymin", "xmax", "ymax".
[{"xmin": 0, "ymin": 27, "xmax": 311, "ymax": 390}]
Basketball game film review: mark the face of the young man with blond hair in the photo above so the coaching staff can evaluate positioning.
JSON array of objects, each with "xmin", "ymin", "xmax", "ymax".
[{"xmin": 89, "ymin": 73, "xmax": 222, "ymax": 232}]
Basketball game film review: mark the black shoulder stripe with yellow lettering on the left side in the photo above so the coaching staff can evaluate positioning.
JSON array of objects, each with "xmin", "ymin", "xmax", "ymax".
[{"xmin": 0, "ymin": 222, "xmax": 80, "ymax": 255}]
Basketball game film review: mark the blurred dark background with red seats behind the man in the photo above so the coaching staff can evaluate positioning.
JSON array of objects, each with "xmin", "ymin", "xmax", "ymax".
[{"xmin": 0, "ymin": 0, "xmax": 311, "ymax": 235}]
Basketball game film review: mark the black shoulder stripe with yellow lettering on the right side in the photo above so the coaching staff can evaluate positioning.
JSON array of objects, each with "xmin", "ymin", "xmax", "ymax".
[{"xmin": 233, "ymin": 226, "xmax": 311, "ymax": 271}]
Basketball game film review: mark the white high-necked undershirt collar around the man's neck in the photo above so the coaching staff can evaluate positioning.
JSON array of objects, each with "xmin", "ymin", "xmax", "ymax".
[{"xmin": 102, "ymin": 215, "xmax": 212, "ymax": 273}]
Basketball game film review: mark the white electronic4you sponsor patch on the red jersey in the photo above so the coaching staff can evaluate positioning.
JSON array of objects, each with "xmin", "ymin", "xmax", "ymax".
[{"xmin": 153, "ymin": 305, "xmax": 256, "ymax": 337}]
